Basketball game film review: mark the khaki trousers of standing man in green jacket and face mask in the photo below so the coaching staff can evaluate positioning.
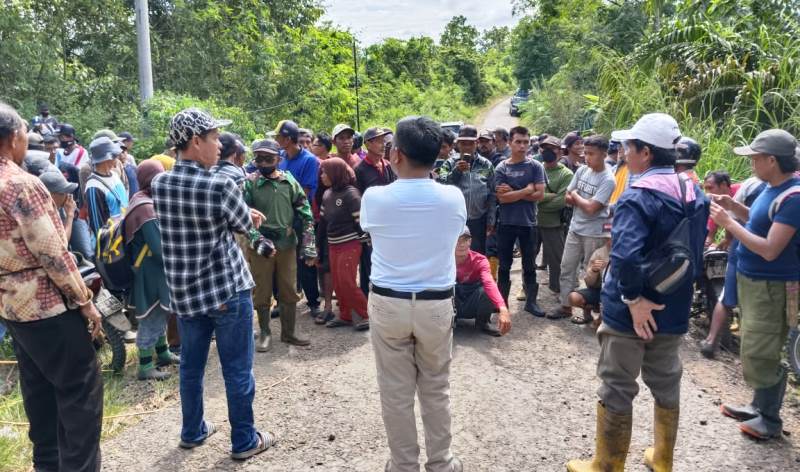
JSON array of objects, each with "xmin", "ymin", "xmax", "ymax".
[{"xmin": 245, "ymin": 247, "xmax": 300, "ymax": 310}]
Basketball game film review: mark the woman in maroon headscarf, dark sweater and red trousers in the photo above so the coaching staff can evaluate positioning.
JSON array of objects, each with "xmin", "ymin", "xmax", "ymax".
[{"xmin": 320, "ymin": 157, "xmax": 369, "ymax": 330}]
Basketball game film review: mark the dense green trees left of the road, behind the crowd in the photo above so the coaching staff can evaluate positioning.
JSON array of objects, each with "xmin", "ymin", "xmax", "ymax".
[{"xmin": 0, "ymin": 0, "xmax": 513, "ymax": 157}]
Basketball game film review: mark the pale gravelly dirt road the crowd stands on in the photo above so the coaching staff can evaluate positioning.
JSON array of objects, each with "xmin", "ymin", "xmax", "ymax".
[{"xmin": 103, "ymin": 98, "xmax": 800, "ymax": 472}]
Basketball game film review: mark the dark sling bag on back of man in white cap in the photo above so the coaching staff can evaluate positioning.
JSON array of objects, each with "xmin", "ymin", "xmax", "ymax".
[{"xmin": 642, "ymin": 176, "xmax": 695, "ymax": 296}]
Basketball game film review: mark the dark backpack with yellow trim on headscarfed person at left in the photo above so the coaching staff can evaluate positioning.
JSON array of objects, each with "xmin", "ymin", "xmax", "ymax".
[{"xmin": 95, "ymin": 196, "xmax": 152, "ymax": 291}]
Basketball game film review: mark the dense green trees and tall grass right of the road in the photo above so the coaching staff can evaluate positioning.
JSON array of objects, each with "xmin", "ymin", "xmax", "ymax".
[{"xmin": 512, "ymin": 0, "xmax": 800, "ymax": 178}]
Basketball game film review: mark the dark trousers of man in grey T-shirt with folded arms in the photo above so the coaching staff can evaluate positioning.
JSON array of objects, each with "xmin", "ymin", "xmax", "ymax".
[{"xmin": 497, "ymin": 225, "xmax": 539, "ymax": 303}]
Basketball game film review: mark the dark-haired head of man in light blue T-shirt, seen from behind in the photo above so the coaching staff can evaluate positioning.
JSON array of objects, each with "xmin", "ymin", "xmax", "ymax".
[{"xmin": 394, "ymin": 116, "xmax": 442, "ymax": 168}]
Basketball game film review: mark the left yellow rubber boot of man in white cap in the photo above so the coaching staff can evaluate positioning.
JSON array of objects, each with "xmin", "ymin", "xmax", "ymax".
[{"xmin": 567, "ymin": 402, "xmax": 633, "ymax": 472}]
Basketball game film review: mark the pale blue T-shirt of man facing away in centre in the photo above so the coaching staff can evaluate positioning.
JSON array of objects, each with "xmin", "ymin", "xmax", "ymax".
[{"xmin": 360, "ymin": 179, "xmax": 467, "ymax": 292}]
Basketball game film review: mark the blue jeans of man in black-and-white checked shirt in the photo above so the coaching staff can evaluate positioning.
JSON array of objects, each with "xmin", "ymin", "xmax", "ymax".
[{"xmin": 178, "ymin": 290, "xmax": 258, "ymax": 453}]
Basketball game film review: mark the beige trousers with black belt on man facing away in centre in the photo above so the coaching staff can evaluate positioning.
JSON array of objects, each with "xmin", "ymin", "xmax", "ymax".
[{"xmin": 368, "ymin": 292, "xmax": 455, "ymax": 472}]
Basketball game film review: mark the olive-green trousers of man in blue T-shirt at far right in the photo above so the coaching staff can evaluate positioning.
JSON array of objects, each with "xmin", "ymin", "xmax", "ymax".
[{"xmin": 736, "ymin": 273, "xmax": 789, "ymax": 388}]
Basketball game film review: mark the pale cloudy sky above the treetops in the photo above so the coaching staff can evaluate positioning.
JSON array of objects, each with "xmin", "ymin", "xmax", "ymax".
[{"xmin": 323, "ymin": 0, "xmax": 516, "ymax": 46}]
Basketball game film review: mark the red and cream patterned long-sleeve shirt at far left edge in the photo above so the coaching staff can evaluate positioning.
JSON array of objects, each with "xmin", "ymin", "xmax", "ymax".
[{"xmin": 0, "ymin": 157, "xmax": 92, "ymax": 322}]
